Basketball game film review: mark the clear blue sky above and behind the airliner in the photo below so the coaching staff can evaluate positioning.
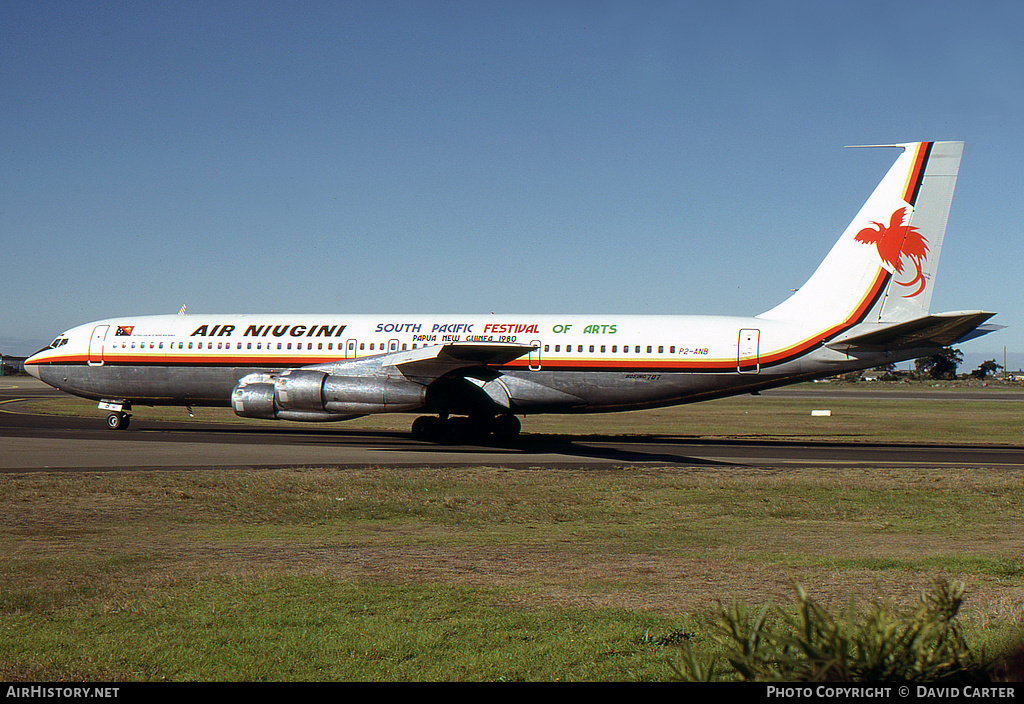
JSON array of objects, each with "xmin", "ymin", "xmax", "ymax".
[{"xmin": 0, "ymin": 0, "xmax": 1024, "ymax": 366}]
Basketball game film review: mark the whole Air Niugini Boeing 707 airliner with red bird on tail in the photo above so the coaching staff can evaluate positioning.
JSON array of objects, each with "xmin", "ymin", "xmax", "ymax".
[{"xmin": 25, "ymin": 141, "xmax": 1001, "ymax": 442}]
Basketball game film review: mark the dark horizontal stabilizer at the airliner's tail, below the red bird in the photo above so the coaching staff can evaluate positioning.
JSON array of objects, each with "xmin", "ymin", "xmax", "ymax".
[{"xmin": 825, "ymin": 310, "xmax": 1005, "ymax": 352}]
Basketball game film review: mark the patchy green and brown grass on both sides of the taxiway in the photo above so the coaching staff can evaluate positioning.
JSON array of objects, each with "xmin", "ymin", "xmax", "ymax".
[{"xmin": 0, "ymin": 386, "xmax": 1024, "ymax": 680}]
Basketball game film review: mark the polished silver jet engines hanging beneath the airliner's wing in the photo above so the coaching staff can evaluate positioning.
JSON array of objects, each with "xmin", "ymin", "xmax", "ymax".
[{"xmin": 231, "ymin": 369, "xmax": 426, "ymax": 421}]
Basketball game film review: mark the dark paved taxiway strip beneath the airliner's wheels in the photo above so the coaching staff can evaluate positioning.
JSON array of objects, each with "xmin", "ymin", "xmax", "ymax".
[{"xmin": 0, "ymin": 378, "xmax": 1024, "ymax": 473}]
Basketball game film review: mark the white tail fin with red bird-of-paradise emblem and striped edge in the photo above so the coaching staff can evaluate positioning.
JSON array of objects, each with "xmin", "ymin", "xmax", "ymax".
[{"xmin": 758, "ymin": 142, "xmax": 964, "ymax": 325}]
